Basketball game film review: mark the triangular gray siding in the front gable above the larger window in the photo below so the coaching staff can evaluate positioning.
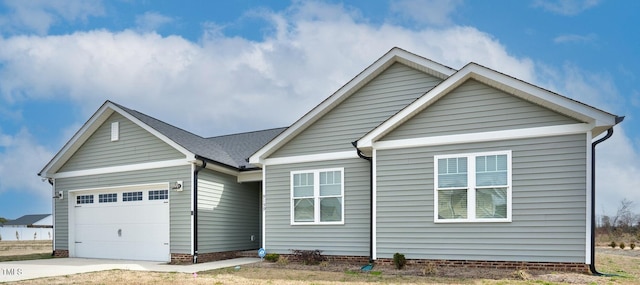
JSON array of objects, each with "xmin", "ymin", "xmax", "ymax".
[{"xmin": 383, "ymin": 80, "xmax": 578, "ymax": 140}]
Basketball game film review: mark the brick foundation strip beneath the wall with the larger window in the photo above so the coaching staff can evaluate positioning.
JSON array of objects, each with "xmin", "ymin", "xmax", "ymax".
[{"xmin": 376, "ymin": 258, "xmax": 590, "ymax": 274}]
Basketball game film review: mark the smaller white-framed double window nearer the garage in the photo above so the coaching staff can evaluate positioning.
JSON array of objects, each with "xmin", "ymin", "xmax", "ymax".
[{"xmin": 291, "ymin": 168, "xmax": 344, "ymax": 224}]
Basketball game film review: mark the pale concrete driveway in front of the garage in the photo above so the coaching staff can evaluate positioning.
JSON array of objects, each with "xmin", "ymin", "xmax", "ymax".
[{"xmin": 0, "ymin": 257, "xmax": 260, "ymax": 283}]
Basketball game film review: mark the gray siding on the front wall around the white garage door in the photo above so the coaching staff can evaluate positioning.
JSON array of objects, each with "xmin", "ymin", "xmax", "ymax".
[{"xmin": 55, "ymin": 165, "xmax": 191, "ymax": 254}]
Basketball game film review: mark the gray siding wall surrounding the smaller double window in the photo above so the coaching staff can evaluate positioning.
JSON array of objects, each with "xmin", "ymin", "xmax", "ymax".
[{"xmin": 265, "ymin": 159, "xmax": 370, "ymax": 256}]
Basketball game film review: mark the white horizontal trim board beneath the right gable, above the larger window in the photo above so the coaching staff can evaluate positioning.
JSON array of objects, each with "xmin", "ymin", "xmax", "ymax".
[{"xmin": 373, "ymin": 123, "xmax": 593, "ymax": 150}]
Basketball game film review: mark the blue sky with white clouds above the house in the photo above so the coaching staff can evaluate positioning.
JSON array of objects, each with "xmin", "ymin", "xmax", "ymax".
[{"xmin": 0, "ymin": 0, "xmax": 640, "ymax": 219}]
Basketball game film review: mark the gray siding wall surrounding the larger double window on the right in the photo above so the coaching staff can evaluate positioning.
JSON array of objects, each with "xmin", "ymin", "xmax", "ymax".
[{"xmin": 376, "ymin": 134, "xmax": 589, "ymax": 263}]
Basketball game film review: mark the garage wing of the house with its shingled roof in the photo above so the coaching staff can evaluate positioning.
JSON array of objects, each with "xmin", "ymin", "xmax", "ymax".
[{"xmin": 39, "ymin": 101, "xmax": 282, "ymax": 262}]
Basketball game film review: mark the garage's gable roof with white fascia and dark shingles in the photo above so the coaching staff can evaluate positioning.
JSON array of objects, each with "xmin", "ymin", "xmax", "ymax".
[{"xmin": 38, "ymin": 101, "xmax": 284, "ymax": 177}]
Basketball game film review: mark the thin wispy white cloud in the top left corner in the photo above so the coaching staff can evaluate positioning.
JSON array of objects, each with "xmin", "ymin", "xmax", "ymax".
[{"xmin": 0, "ymin": 0, "xmax": 104, "ymax": 35}]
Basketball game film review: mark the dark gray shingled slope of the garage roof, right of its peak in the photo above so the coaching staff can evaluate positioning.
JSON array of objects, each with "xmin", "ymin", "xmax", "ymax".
[{"xmin": 111, "ymin": 102, "xmax": 286, "ymax": 170}]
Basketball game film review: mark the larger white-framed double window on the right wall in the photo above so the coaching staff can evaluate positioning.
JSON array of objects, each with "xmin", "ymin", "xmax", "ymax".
[{"xmin": 434, "ymin": 151, "xmax": 511, "ymax": 222}]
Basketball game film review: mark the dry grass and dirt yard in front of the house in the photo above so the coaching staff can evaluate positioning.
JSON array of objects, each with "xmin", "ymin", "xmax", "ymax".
[{"xmin": 5, "ymin": 245, "xmax": 640, "ymax": 285}]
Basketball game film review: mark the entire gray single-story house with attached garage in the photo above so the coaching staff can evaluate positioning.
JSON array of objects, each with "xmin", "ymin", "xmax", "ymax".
[{"xmin": 39, "ymin": 48, "xmax": 623, "ymax": 271}]
